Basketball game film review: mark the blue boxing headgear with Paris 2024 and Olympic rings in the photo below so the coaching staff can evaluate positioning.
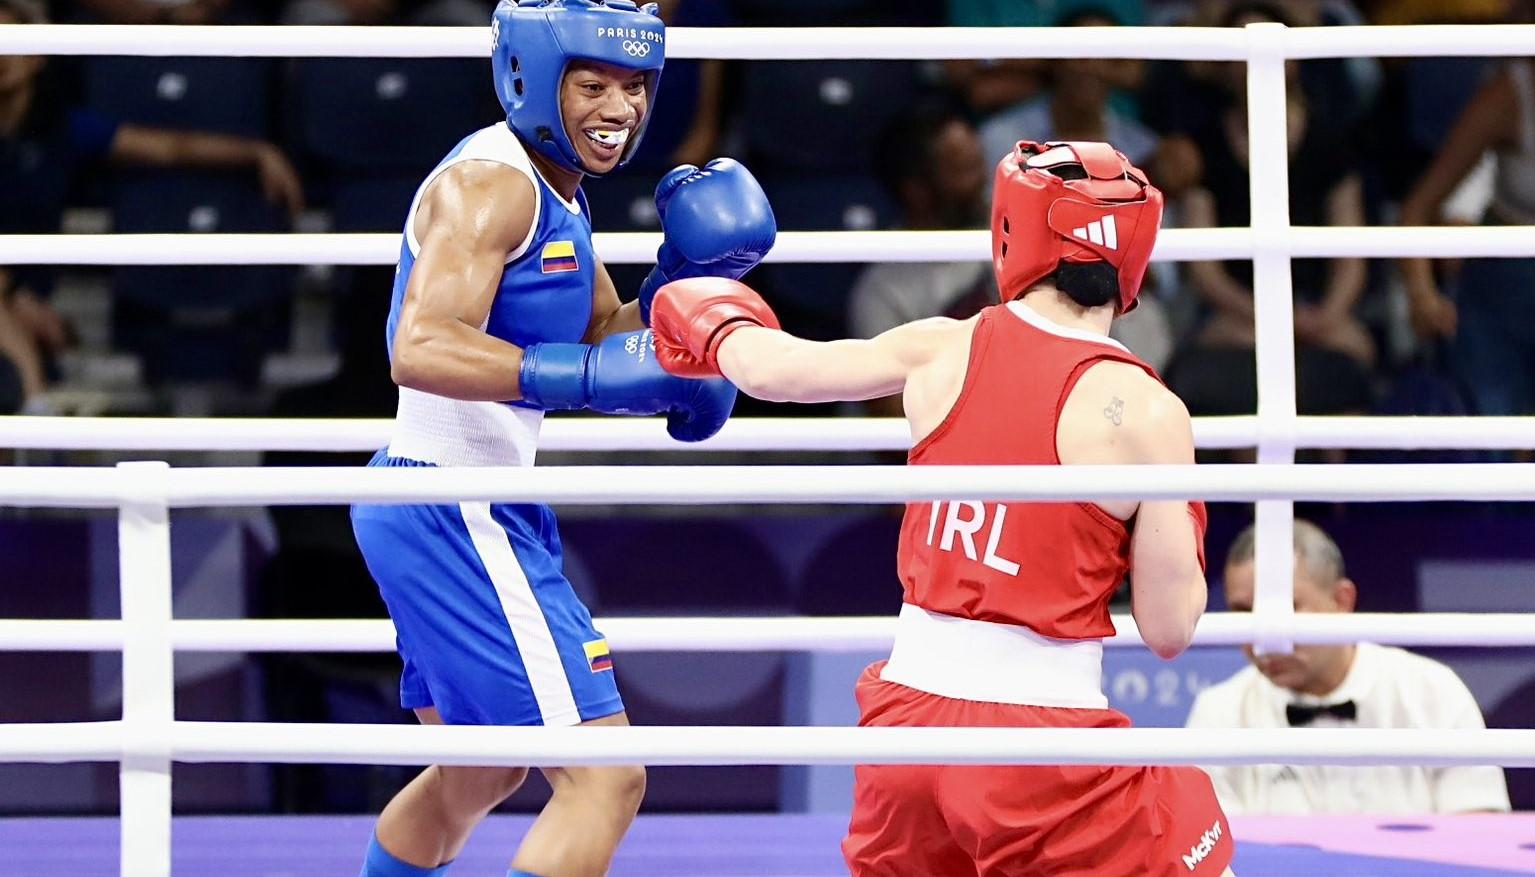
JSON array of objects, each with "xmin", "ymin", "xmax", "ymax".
[{"xmin": 490, "ymin": 0, "xmax": 666, "ymax": 174}]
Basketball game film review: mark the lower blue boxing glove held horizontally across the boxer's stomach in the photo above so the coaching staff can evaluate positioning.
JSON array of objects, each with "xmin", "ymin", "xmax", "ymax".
[{"xmin": 519, "ymin": 329, "xmax": 735, "ymax": 441}]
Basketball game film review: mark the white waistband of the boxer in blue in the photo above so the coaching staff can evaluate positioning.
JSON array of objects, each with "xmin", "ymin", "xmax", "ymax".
[{"xmin": 388, "ymin": 387, "xmax": 543, "ymax": 465}]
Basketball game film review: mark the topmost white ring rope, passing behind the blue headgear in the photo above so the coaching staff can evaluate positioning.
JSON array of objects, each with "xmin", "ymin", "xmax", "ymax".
[{"xmin": 9, "ymin": 25, "xmax": 1535, "ymax": 61}]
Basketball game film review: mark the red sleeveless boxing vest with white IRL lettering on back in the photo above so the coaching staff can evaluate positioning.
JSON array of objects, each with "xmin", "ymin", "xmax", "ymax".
[{"xmin": 896, "ymin": 304, "xmax": 1157, "ymax": 639}]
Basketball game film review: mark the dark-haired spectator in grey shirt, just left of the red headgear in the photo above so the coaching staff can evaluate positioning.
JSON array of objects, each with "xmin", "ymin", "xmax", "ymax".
[{"xmin": 849, "ymin": 100, "xmax": 1001, "ymax": 416}]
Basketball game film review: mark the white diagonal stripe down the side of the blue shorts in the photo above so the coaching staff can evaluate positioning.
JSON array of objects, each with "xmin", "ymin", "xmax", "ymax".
[{"xmin": 459, "ymin": 502, "xmax": 580, "ymax": 725}]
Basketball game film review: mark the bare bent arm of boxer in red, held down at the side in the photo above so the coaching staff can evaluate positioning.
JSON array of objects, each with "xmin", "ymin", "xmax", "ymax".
[{"xmin": 1124, "ymin": 379, "xmax": 1208, "ymax": 659}]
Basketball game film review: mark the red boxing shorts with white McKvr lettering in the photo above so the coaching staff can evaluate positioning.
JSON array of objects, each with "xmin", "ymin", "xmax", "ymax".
[{"xmin": 843, "ymin": 662, "xmax": 1233, "ymax": 877}]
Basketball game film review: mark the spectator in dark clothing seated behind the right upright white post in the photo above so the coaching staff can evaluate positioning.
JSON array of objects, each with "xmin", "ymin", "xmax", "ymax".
[{"xmin": 1168, "ymin": 3, "xmax": 1375, "ymax": 415}]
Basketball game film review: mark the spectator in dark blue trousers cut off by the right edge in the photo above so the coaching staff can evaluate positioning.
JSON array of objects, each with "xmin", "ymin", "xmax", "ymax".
[{"xmin": 1401, "ymin": 0, "xmax": 1535, "ymax": 415}]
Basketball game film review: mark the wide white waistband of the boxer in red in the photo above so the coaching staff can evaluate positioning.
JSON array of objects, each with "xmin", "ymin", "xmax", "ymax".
[{"xmin": 880, "ymin": 604, "xmax": 1108, "ymax": 710}]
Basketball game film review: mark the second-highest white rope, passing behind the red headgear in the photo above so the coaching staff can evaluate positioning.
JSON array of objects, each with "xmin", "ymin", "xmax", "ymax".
[{"xmin": 0, "ymin": 226, "xmax": 1535, "ymax": 266}]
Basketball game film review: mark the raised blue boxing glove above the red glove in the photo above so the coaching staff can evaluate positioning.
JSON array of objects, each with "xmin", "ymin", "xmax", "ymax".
[{"xmin": 640, "ymin": 158, "xmax": 778, "ymax": 326}]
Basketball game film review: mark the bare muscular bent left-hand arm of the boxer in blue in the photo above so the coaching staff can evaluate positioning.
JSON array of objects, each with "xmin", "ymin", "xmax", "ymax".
[{"xmin": 390, "ymin": 161, "xmax": 537, "ymax": 402}]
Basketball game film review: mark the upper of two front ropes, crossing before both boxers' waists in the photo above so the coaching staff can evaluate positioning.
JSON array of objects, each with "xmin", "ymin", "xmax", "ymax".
[{"xmin": 0, "ymin": 462, "xmax": 1535, "ymax": 508}]
